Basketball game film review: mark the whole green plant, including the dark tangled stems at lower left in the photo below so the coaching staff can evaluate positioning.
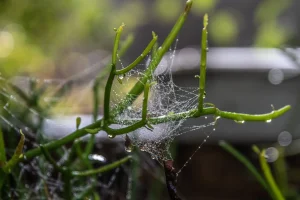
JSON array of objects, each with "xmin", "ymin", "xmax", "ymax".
[{"xmin": 0, "ymin": 0, "xmax": 290, "ymax": 199}]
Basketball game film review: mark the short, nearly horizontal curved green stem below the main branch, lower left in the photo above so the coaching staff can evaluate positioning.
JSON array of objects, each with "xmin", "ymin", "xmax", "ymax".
[{"xmin": 72, "ymin": 156, "xmax": 131, "ymax": 176}]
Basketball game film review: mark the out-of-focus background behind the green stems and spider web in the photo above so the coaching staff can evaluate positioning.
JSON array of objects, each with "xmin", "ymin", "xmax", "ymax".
[{"xmin": 0, "ymin": 0, "xmax": 300, "ymax": 200}]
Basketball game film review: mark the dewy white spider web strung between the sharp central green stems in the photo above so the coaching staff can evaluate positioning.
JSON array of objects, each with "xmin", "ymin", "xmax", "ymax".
[{"xmin": 112, "ymin": 39, "xmax": 215, "ymax": 163}]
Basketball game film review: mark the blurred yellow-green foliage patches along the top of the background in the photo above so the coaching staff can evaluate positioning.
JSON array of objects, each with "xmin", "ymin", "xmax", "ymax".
[{"xmin": 0, "ymin": 0, "xmax": 294, "ymax": 77}]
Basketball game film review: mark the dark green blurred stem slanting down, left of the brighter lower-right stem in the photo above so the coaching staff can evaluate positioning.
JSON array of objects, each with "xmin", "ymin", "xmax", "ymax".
[{"xmin": 219, "ymin": 141, "xmax": 272, "ymax": 195}]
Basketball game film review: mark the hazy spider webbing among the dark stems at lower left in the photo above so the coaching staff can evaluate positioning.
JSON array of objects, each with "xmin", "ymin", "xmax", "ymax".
[{"xmin": 0, "ymin": 72, "xmax": 127, "ymax": 199}]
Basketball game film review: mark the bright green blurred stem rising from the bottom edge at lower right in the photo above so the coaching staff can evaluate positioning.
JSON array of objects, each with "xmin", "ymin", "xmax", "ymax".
[{"xmin": 259, "ymin": 150, "xmax": 285, "ymax": 200}]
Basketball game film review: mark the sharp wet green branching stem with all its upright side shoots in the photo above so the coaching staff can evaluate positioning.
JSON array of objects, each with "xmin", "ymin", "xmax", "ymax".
[{"xmin": 4, "ymin": 0, "xmax": 291, "ymax": 198}]
